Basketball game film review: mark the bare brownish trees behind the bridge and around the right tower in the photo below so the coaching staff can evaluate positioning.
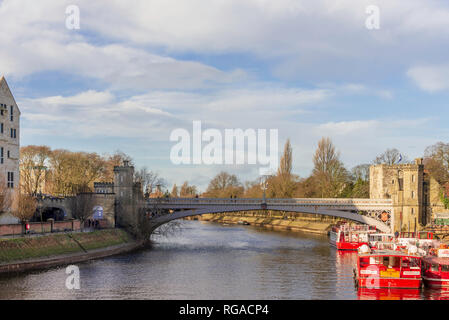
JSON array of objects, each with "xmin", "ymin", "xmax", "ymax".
[{"xmin": 170, "ymin": 137, "xmax": 449, "ymax": 200}]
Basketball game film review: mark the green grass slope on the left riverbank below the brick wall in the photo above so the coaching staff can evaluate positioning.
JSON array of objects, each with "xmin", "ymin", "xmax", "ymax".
[{"xmin": 0, "ymin": 229, "xmax": 132, "ymax": 264}]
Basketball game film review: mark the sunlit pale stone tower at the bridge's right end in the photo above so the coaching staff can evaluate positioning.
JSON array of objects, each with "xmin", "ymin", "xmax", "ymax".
[{"xmin": 370, "ymin": 159, "xmax": 429, "ymax": 231}]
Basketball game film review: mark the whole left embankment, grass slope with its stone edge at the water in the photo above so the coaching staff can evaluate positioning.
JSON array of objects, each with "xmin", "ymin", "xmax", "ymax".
[{"xmin": 0, "ymin": 229, "xmax": 141, "ymax": 273}]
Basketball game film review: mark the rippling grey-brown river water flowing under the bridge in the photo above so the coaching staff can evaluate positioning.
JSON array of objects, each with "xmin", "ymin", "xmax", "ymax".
[{"xmin": 0, "ymin": 221, "xmax": 449, "ymax": 300}]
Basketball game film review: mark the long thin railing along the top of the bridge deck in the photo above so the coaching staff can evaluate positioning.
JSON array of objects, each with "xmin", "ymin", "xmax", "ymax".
[{"xmin": 148, "ymin": 198, "xmax": 392, "ymax": 206}]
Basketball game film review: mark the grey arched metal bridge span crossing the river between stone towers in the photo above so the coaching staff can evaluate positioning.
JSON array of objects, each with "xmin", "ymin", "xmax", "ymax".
[{"xmin": 146, "ymin": 198, "xmax": 394, "ymax": 233}]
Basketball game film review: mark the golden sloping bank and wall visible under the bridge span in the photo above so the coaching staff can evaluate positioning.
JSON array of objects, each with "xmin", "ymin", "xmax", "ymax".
[{"xmin": 192, "ymin": 212, "xmax": 341, "ymax": 235}]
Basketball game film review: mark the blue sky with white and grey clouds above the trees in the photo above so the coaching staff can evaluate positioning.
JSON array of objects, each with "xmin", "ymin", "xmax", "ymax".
[{"xmin": 0, "ymin": 0, "xmax": 449, "ymax": 189}]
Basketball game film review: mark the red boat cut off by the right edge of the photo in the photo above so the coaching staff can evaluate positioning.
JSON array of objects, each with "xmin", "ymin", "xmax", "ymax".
[{"xmin": 423, "ymin": 247, "xmax": 449, "ymax": 288}]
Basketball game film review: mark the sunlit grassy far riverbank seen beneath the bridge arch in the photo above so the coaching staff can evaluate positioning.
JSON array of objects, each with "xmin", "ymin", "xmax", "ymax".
[{"xmin": 198, "ymin": 213, "xmax": 335, "ymax": 234}]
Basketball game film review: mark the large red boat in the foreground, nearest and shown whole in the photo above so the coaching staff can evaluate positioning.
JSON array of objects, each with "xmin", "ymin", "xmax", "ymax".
[{"xmin": 355, "ymin": 247, "xmax": 422, "ymax": 289}]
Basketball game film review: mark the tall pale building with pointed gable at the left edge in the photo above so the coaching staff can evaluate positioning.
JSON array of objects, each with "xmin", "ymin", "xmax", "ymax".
[{"xmin": 0, "ymin": 76, "xmax": 20, "ymax": 223}]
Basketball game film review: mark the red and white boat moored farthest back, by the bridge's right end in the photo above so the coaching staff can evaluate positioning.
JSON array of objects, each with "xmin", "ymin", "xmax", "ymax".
[{"xmin": 329, "ymin": 224, "xmax": 376, "ymax": 251}]
